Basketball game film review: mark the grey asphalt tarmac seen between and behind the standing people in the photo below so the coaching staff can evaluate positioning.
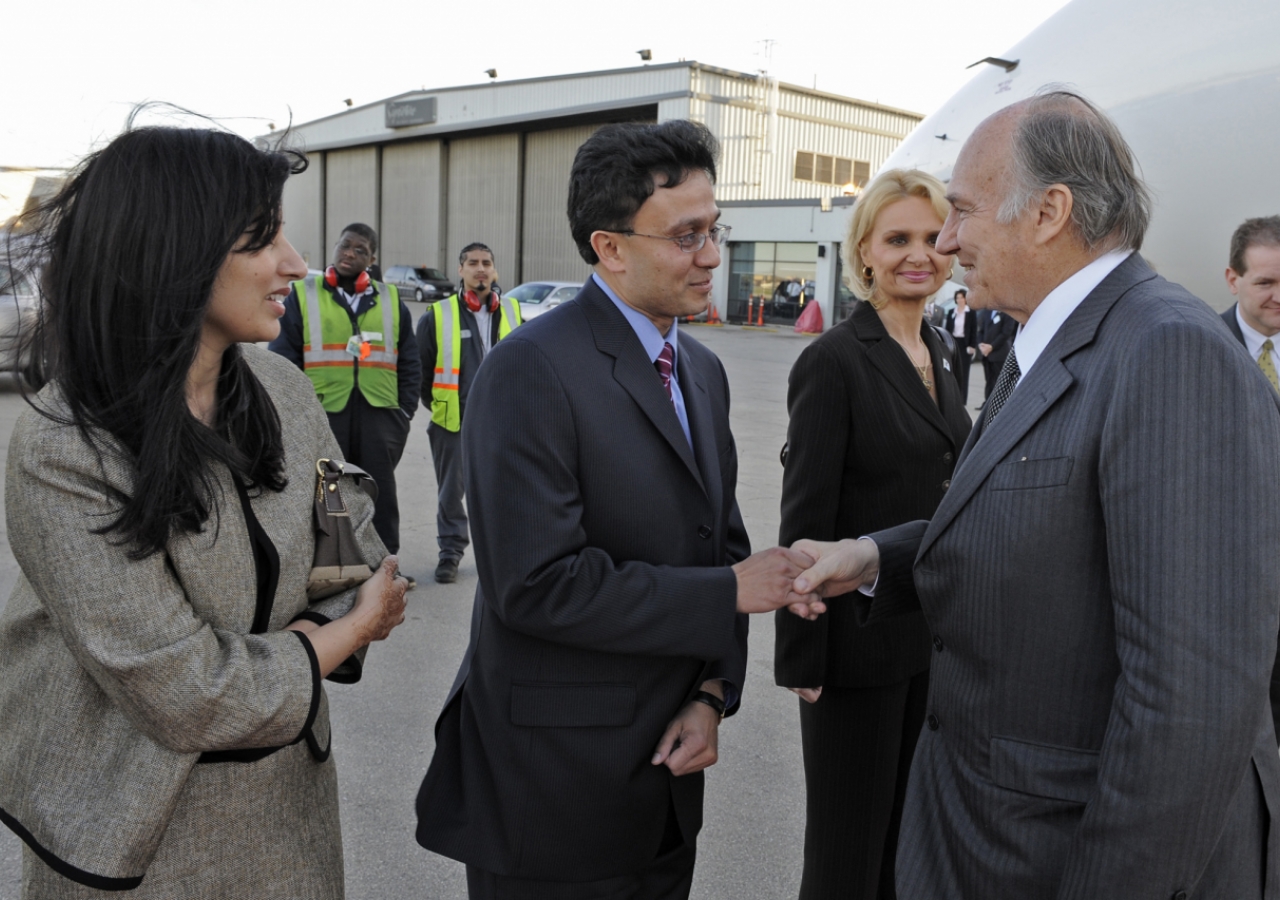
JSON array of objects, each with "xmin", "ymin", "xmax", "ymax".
[{"xmin": 0, "ymin": 323, "xmax": 982, "ymax": 900}]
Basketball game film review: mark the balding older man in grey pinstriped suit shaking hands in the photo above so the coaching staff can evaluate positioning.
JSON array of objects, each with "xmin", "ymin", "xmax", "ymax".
[{"xmin": 795, "ymin": 91, "xmax": 1280, "ymax": 900}]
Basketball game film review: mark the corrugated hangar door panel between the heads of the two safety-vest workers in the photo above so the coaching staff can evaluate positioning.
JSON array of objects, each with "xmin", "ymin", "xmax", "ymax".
[{"xmin": 378, "ymin": 141, "xmax": 448, "ymax": 270}]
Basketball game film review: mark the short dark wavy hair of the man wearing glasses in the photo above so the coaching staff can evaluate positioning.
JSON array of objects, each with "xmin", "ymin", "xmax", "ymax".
[{"xmin": 568, "ymin": 119, "xmax": 719, "ymax": 265}]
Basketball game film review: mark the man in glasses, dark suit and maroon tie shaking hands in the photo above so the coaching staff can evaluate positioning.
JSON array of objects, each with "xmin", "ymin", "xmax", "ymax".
[{"xmin": 417, "ymin": 120, "xmax": 822, "ymax": 900}]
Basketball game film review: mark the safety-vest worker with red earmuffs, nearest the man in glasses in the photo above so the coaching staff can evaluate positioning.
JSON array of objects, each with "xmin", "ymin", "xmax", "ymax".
[{"xmin": 417, "ymin": 243, "xmax": 521, "ymax": 584}]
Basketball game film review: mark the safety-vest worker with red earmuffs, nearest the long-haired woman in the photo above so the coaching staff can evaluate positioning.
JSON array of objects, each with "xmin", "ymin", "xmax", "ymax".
[{"xmin": 270, "ymin": 223, "xmax": 421, "ymax": 565}]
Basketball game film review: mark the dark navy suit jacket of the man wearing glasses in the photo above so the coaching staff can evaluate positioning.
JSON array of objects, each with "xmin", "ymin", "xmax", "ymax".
[{"xmin": 417, "ymin": 280, "xmax": 750, "ymax": 881}]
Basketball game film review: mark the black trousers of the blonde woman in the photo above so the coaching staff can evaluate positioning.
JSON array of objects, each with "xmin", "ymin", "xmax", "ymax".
[{"xmin": 800, "ymin": 672, "xmax": 929, "ymax": 900}]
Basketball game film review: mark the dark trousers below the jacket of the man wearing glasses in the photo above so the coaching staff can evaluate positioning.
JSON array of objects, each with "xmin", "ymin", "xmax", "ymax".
[{"xmin": 467, "ymin": 807, "xmax": 696, "ymax": 900}]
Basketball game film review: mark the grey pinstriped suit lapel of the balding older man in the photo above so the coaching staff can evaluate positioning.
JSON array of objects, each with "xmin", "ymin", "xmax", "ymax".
[{"xmin": 916, "ymin": 253, "xmax": 1156, "ymax": 559}]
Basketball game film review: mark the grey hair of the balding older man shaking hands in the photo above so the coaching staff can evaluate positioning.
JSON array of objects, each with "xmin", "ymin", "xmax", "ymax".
[{"xmin": 996, "ymin": 87, "xmax": 1151, "ymax": 251}]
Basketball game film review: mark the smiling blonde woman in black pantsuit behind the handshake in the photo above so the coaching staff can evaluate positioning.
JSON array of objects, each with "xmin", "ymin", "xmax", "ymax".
[{"xmin": 774, "ymin": 170, "xmax": 970, "ymax": 900}]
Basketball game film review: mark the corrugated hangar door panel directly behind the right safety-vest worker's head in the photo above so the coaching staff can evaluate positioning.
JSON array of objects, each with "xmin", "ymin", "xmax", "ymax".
[{"xmin": 445, "ymin": 134, "xmax": 521, "ymax": 288}]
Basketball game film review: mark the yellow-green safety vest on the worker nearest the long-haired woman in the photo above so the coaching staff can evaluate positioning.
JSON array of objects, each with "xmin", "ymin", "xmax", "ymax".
[{"xmin": 293, "ymin": 275, "xmax": 399, "ymax": 412}]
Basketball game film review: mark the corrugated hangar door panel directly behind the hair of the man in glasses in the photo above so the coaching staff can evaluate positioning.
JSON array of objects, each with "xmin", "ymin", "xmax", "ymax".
[{"xmin": 512, "ymin": 125, "xmax": 599, "ymax": 281}]
